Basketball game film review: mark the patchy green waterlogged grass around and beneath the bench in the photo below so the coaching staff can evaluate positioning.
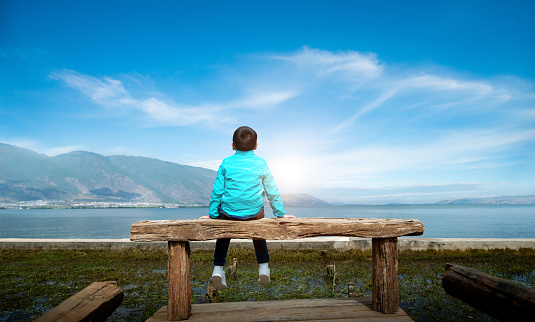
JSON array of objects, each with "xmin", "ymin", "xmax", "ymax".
[{"xmin": 0, "ymin": 248, "xmax": 535, "ymax": 321}]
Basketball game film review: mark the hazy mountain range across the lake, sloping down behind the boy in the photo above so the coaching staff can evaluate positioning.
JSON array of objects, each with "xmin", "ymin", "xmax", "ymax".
[{"xmin": 0, "ymin": 143, "xmax": 328, "ymax": 206}]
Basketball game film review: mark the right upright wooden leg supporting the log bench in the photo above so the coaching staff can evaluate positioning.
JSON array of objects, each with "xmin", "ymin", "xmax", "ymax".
[{"xmin": 372, "ymin": 238, "xmax": 399, "ymax": 314}]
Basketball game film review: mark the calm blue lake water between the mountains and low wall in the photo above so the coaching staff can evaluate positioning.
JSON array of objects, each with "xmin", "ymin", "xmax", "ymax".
[{"xmin": 0, "ymin": 205, "xmax": 535, "ymax": 239}]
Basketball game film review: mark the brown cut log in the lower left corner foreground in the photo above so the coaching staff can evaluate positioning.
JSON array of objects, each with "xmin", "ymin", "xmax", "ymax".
[{"xmin": 35, "ymin": 281, "xmax": 124, "ymax": 322}]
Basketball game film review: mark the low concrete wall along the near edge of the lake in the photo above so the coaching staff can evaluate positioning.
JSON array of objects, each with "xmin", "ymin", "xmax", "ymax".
[{"xmin": 0, "ymin": 237, "xmax": 535, "ymax": 251}]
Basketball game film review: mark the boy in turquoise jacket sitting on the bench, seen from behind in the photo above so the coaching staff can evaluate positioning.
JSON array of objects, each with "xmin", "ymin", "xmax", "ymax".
[{"xmin": 201, "ymin": 126, "xmax": 295, "ymax": 290}]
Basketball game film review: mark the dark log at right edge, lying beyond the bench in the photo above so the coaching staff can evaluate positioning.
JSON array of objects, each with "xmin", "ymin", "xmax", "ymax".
[{"xmin": 442, "ymin": 264, "xmax": 535, "ymax": 321}]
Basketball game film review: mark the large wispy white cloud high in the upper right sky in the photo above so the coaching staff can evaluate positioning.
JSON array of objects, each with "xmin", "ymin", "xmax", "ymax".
[{"xmin": 273, "ymin": 47, "xmax": 533, "ymax": 141}]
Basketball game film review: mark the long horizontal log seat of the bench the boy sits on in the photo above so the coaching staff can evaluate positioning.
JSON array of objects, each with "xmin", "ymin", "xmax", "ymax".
[{"xmin": 130, "ymin": 218, "xmax": 425, "ymax": 241}]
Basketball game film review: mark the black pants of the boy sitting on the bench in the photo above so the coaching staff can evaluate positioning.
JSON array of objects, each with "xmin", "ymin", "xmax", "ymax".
[{"xmin": 214, "ymin": 207, "xmax": 269, "ymax": 266}]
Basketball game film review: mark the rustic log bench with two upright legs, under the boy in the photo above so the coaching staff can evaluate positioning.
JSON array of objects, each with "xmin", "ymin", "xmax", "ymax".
[{"xmin": 130, "ymin": 218, "xmax": 424, "ymax": 321}]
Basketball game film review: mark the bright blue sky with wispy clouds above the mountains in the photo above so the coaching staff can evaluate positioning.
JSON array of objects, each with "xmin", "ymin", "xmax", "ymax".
[{"xmin": 0, "ymin": 0, "xmax": 535, "ymax": 204}]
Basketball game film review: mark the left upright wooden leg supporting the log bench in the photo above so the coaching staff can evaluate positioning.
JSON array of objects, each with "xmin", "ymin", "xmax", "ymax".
[{"xmin": 167, "ymin": 241, "xmax": 191, "ymax": 321}]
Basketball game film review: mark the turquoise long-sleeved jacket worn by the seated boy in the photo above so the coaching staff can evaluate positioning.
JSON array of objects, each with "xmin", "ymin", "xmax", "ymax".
[{"xmin": 210, "ymin": 150, "xmax": 286, "ymax": 218}]
